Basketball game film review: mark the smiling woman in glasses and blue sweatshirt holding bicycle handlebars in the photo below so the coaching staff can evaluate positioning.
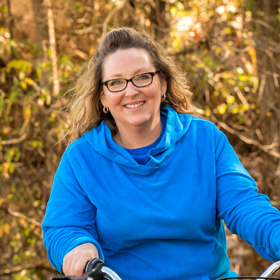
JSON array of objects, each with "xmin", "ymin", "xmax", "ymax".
[{"xmin": 43, "ymin": 28, "xmax": 280, "ymax": 280}]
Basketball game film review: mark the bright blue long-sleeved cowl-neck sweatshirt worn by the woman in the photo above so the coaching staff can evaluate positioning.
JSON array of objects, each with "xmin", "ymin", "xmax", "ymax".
[{"xmin": 42, "ymin": 106, "xmax": 280, "ymax": 280}]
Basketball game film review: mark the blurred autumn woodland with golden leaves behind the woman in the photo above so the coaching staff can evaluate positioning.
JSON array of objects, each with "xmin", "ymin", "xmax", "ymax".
[{"xmin": 0, "ymin": 0, "xmax": 280, "ymax": 280}]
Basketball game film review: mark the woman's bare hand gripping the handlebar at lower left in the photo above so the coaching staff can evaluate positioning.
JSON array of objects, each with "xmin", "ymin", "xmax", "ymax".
[{"xmin": 62, "ymin": 243, "xmax": 99, "ymax": 277}]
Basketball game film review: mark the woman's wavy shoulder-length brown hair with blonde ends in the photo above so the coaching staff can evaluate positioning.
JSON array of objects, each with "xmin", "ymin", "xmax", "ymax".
[{"xmin": 69, "ymin": 28, "xmax": 195, "ymax": 143}]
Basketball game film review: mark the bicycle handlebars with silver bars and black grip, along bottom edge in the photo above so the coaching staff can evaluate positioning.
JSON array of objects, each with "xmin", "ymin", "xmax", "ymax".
[{"xmin": 52, "ymin": 259, "xmax": 280, "ymax": 280}]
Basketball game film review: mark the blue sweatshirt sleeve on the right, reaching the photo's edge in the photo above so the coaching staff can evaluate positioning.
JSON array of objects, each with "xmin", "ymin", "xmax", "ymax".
[{"xmin": 215, "ymin": 130, "xmax": 280, "ymax": 261}]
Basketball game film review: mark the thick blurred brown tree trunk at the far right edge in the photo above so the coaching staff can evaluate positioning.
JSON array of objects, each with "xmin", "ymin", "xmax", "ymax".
[{"xmin": 252, "ymin": 0, "xmax": 280, "ymax": 197}]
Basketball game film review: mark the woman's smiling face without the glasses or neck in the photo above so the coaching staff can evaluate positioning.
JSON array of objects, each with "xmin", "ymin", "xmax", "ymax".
[{"xmin": 101, "ymin": 48, "xmax": 166, "ymax": 133}]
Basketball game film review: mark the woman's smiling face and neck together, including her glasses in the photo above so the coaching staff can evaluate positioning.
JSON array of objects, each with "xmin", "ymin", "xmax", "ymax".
[{"xmin": 101, "ymin": 48, "xmax": 167, "ymax": 149}]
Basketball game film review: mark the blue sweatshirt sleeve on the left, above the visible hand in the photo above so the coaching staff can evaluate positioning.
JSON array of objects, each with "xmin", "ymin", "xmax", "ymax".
[{"xmin": 42, "ymin": 151, "xmax": 104, "ymax": 271}]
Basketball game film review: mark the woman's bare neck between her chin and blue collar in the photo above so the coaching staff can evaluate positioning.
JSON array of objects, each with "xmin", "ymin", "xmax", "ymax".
[{"xmin": 113, "ymin": 118, "xmax": 162, "ymax": 149}]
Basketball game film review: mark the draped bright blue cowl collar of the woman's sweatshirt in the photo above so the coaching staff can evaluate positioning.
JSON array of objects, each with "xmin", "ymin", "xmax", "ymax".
[{"xmin": 84, "ymin": 106, "xmax": 192, "ymax": 175}]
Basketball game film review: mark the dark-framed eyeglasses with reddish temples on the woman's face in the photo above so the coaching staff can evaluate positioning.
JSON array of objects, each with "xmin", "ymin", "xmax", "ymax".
[{"xmin": 100, "ymin": 71, "xmax": 160, "ymax": 92}]
